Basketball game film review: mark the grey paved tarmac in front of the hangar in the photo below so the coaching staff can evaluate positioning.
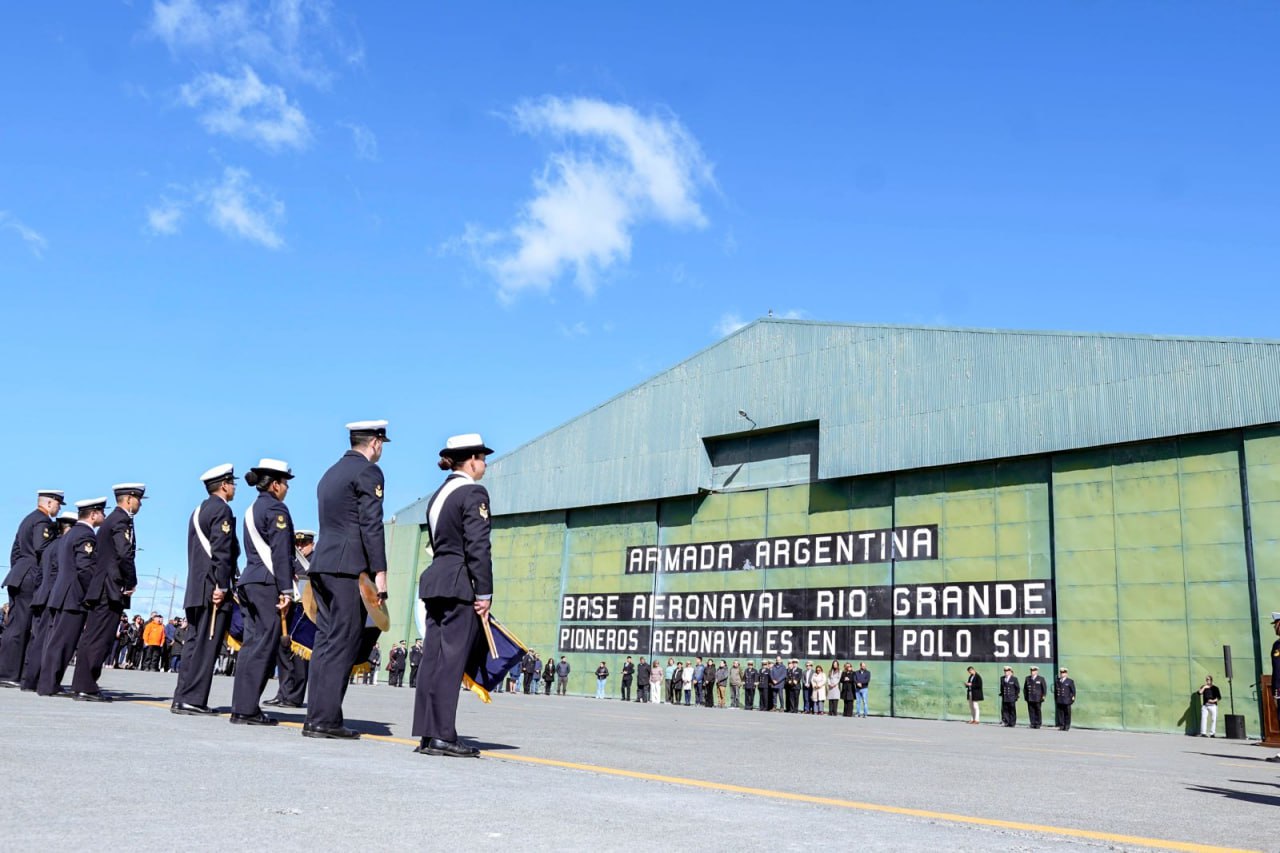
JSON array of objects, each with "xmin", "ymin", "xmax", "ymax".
[{"xmin": 0, "ymin": 670, "xmax": 1280, "ymax": 852}]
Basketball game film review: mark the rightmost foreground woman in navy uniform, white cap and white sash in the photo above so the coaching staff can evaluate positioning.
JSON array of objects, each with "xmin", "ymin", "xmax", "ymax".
[{"xmin": 413, "ymin": 433, "xmax": 491, "ymax": 758}]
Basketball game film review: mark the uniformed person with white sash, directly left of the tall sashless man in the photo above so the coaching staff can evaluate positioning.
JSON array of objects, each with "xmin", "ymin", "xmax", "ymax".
[{"xmin": 232, "ymin": 459, "xmax": 293, "ymax": 726}]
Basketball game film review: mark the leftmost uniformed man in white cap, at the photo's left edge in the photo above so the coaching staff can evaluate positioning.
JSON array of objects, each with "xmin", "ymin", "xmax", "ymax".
[{"xmin": 0, "ymin": 489, "xmax": 63, "ymax": 688}]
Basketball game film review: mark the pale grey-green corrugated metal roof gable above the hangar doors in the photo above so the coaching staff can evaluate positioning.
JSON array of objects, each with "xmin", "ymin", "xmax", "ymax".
[{"xmin": 398, "ymin": 318, "xmax": 1280, "ymax": 520}]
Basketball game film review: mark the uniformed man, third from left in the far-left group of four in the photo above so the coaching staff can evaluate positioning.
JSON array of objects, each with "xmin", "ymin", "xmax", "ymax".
[{"xmin": 36, "ymin": 497, "xmax": 106, "ymax": 695}]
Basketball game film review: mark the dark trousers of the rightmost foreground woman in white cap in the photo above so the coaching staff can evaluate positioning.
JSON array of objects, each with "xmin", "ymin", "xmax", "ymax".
[{"xmin": 413, "ymin": 598, "xmax": 480, "ymax": 743}]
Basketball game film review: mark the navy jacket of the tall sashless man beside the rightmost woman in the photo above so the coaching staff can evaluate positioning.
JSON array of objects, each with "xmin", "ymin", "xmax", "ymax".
[{"xmin": 310, "ymin": 450, "xmax": 387, "ymax": 578}]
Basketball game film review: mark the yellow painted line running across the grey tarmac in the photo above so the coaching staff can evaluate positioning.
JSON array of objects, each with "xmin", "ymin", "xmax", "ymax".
[{"xmin": 138, "ymin": 702, "xmax": 1257, "ymax": 853}]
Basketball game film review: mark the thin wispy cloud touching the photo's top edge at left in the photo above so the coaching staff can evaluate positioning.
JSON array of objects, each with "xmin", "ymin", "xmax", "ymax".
[{"xmin": 148, "ymin": 0, "xmax": 350, "ymax": 88}]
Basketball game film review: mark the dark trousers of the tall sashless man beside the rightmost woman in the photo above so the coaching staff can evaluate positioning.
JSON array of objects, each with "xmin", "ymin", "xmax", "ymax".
[{"xmin": 307, "ymin": 571, "xmax": 365, "ymax": 726}]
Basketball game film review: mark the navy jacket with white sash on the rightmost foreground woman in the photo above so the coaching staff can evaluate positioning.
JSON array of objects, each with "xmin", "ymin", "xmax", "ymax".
[{"xmin": 417, "ymin": 471, "xmax": 493, "ymax": 601}]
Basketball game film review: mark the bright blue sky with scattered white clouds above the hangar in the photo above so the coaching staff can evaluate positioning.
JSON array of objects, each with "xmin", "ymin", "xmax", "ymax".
[{"xmin": 0, "ymin": 0, "xmax": 1280, "ymax": 607}]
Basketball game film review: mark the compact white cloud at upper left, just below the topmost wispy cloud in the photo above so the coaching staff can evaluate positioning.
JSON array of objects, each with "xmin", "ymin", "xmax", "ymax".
[{"xmin": 180, "ymin": 65, "xmax": 311, "ymax": 151}]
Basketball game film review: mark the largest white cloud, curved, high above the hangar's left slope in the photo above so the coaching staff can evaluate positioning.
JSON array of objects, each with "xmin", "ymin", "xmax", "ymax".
[{"xmin": 462, "ymin": 97, "xmax": 714, "ymax": 300}]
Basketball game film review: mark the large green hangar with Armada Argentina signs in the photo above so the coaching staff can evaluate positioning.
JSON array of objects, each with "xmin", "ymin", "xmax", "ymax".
[{"xmin": 378, "ymin": 319, "xmax": 1280, "ymax": 734}]
